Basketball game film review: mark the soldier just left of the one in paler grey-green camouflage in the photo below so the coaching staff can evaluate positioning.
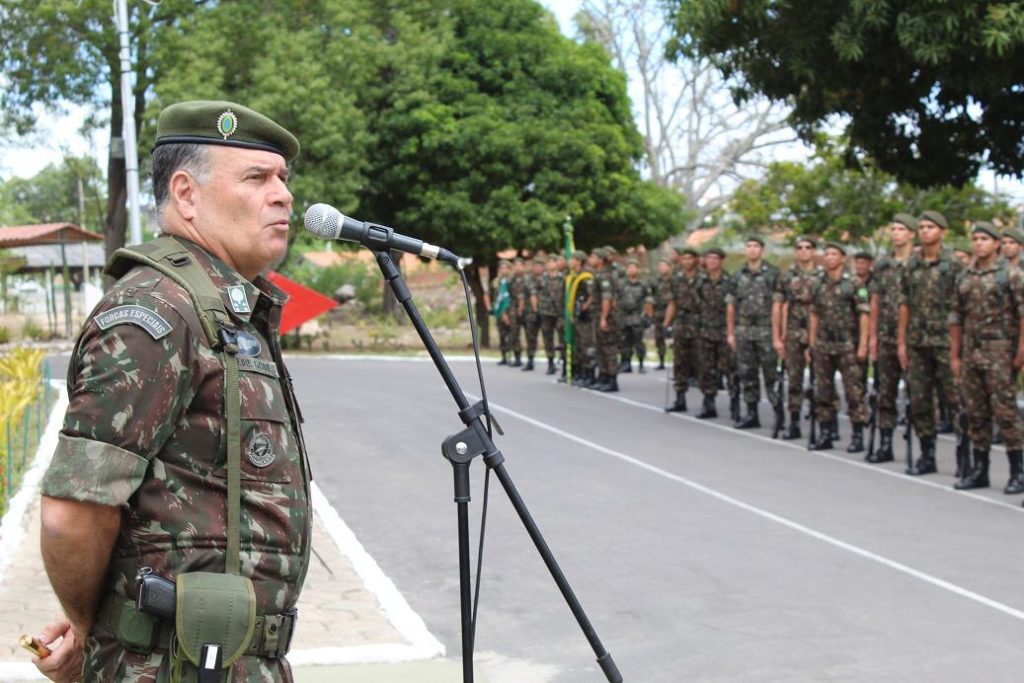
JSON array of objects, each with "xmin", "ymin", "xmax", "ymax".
[{"xmin": 697, "ymin": 247, "xmax": 739, "ymax": 422}]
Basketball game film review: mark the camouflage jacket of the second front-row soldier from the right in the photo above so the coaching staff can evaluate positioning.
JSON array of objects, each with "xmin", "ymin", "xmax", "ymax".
[{"xmin": 900, "ymin": 249, "xmax": 964, "ymax": 346}]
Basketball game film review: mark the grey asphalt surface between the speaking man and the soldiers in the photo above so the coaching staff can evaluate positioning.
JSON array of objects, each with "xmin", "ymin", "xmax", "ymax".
[{"xmin": 46, "ymin": 357, "xmax": 1024, "ymax": 683}]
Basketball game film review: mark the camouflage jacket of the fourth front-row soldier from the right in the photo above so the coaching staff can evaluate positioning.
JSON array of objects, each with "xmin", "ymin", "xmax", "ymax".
[{"xmin": 811, "ymin": 272, "xmax": 871, "ymax": 353}]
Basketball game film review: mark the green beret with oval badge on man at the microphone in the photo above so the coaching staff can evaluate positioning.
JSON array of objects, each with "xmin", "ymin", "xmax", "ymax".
[{"xmin": 154, "ymin": 99, "xmax": 299, "ymax": 161}]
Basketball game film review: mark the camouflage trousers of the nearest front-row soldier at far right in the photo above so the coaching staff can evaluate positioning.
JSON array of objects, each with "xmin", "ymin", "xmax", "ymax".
[{"xmin": 959, "ymin": 341, "xmax": 1022, "ymax": 451}]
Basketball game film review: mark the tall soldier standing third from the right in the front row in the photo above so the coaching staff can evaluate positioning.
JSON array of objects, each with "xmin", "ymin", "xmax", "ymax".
[{"xmin": 867, "ymin": 213, "xmax": 918, "ymax": 463}]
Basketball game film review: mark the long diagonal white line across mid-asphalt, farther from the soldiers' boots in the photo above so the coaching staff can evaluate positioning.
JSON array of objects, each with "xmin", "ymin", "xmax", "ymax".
[{"xmin": 479, "ymin": 399, "xmax": 1024, "ymax": 621}]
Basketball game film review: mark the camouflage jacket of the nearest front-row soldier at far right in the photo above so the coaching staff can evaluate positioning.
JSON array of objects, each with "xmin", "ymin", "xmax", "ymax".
[{"xmin": 949, "ymin": 262, "xmax": 1024, "ymax": 348}]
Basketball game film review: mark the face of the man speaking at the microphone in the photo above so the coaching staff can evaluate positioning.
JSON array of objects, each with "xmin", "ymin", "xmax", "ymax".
[{"xmin": 190, "ymin": 145, "xmax": 292, "ymax": 280}]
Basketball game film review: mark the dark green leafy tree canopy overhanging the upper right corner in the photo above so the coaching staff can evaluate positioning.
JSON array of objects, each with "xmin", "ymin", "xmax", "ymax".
[{"xmin": 669, "ymin": 0, "xmax": 1024, "ymax": 186}]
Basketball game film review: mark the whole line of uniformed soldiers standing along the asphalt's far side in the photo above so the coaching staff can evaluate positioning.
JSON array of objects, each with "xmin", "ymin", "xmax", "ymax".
[{"xmin": 492, "ymin": 211, "xmax": 1024, "ymax": 505}]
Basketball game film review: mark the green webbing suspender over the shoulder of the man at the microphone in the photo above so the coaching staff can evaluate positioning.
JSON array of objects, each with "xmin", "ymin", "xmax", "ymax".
[{"xmin": 105, "ymin": 238, "xmax": 242, "ymax": 574}]
